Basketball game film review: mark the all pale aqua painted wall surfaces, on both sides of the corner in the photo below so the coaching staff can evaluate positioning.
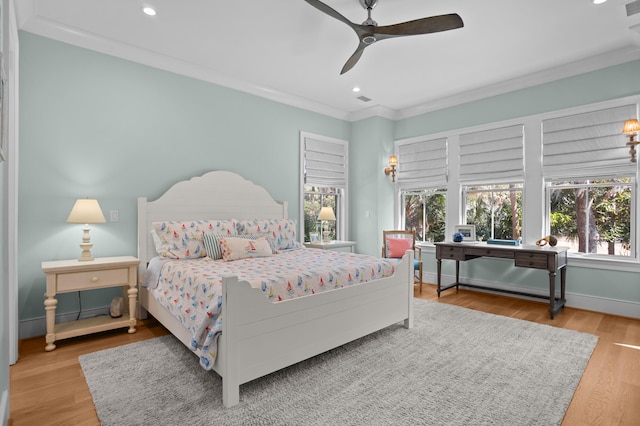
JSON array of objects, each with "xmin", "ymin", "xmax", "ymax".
[{"xmin": 18, "ymin": 32, "xmax": 640, "ymax": 337}]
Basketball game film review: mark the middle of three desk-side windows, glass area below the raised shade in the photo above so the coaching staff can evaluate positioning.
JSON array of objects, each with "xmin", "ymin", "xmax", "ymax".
[{"xmin": 463, "ymin": 183, "xmax": 522, "ymax": 241}]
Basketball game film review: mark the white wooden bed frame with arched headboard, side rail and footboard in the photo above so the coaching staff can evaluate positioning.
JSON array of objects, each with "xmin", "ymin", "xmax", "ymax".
[{"xmin": 138, "ymin": 171, "xmax": 413, "ymax": 407}]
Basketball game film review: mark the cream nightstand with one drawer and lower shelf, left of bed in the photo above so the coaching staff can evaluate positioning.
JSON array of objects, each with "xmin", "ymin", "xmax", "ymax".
[{"xmin": 42, "ymin": 256, "xmax": 140, "ymax": 351}]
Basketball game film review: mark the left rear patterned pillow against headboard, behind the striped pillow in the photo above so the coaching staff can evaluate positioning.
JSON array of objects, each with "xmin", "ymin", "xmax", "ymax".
[{"xmin": 152, "ymin": 219, "xmax": 236, "ymax": 259}]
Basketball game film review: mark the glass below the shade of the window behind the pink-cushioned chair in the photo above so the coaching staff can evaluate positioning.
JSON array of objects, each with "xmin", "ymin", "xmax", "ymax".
[{"xmin": 402, "ymin": 188, "xmax": 447, "ymax": 243}]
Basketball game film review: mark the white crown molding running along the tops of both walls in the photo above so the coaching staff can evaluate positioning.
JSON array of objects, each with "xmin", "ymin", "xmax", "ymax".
[{"xmin": 16, "ymin": 1, "xmax": 640, "ymax": 122}]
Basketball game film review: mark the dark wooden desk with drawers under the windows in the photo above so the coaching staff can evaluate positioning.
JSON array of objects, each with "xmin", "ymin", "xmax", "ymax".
[{"xmin": 435, "ymin": 242, "xmax": 569, "ymax": 319}]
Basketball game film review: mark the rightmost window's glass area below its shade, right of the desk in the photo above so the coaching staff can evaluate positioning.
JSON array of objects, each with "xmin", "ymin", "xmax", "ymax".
[{"xmin": 547, "ymin": 177, "xmax": 634, "ymax": 257}]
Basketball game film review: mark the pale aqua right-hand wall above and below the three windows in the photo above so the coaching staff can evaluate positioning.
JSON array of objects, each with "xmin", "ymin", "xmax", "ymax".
[{"xmin": 394, "ymin": 61, "xmax": 640, "ymax": 303}]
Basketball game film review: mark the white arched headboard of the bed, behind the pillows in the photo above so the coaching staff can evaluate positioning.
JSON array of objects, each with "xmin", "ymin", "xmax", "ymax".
[{"xmin": 138, "ymin": 171, "xmax": 287, "ymax": 272}]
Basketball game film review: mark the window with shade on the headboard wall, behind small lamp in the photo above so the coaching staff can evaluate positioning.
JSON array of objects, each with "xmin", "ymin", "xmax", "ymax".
[{"xmin": 300, "ymin": 132, "xmax": 348, "ymax": 241}]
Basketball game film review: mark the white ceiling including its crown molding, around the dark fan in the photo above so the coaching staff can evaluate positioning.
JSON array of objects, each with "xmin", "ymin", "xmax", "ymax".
[{"xmin": 15, "ymin": 0, "xmax": 640, "ymax": 120}]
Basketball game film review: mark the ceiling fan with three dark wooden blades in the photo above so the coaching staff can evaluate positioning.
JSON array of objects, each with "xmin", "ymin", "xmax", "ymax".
[{"xmin": 305, "ymin": 0, "xmax": 464, "ymax": 74}]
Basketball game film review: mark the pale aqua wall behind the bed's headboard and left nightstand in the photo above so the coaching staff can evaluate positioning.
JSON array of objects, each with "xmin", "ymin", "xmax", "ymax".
[{"xmin": 18, "ymin": 32, "xmax": 351, "ymax": 320}]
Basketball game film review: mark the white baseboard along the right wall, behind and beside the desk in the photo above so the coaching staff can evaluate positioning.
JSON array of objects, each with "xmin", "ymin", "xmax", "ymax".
[{"xmin": 423, "ymin": 273, "xmax": 640, "ymax": 319}]
